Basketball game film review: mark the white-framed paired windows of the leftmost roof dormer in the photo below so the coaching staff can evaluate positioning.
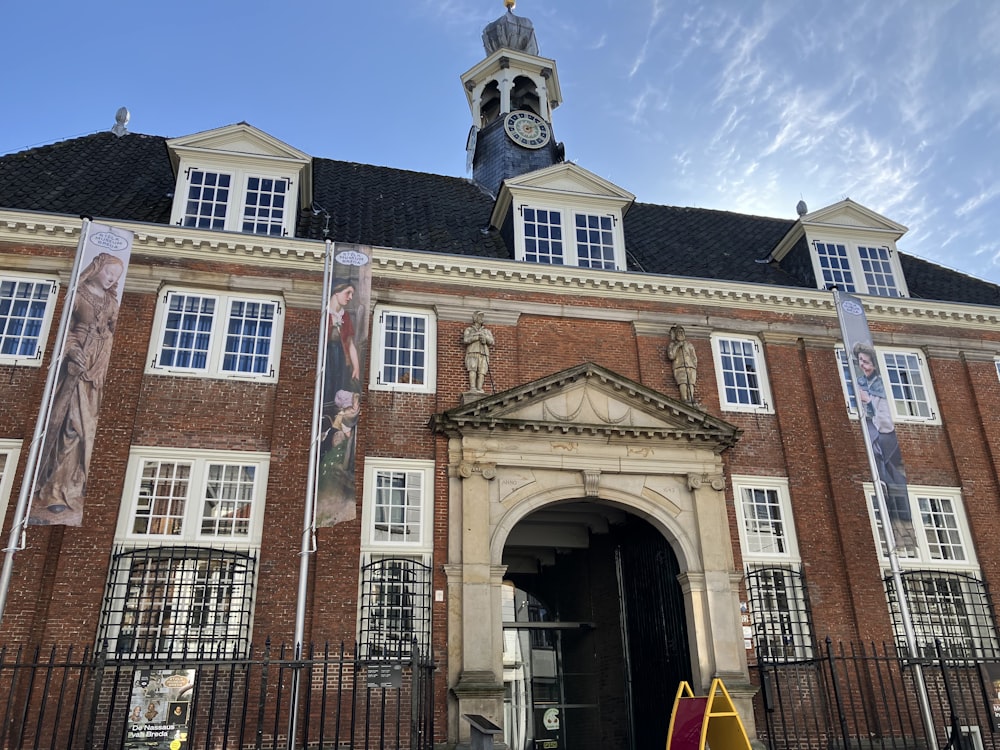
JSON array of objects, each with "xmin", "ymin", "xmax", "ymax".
[{"xmin": 174, "ymin": 167, "xmax": 295, "ymax": 236}]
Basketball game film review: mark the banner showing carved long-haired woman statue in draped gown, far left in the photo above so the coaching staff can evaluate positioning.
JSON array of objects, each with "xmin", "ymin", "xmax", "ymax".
[{"xmin": 28, "ymin": 222, "xmax": 133, "ymax": 526}]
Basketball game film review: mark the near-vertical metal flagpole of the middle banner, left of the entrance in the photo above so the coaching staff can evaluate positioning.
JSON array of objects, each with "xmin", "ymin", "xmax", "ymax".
[{"xmin": 288, "ymin": 240, "xmax": 333, "ymax": 750}]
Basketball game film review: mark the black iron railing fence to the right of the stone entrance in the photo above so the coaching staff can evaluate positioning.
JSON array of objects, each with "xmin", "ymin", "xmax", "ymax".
[{"xmin": 753, "ymin": 639, "xmax": 1000, "ymax": 750}]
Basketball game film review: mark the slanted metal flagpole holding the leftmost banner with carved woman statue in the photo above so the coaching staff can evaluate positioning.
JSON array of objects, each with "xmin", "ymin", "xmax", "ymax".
[{"xmin": 0, "ymin": 216, "xmax": 90, "ymax": 623}]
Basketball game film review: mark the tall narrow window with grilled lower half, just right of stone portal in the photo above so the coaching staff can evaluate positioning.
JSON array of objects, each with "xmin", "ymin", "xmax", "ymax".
[{"xmin": 733, "ymin": 476, "xmax": 813, "ymax": 661}]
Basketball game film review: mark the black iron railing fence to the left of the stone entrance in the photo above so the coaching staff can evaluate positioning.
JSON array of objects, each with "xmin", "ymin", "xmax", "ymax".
[{"xmin": 0, "ymin": 643, "xmax": 435, "ymax": 750}]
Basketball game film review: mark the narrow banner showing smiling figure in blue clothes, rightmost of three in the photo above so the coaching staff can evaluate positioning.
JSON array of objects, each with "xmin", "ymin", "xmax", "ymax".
[{"xmin": 833, "ymin": 289, "xmax": 916, "ymax": 549}]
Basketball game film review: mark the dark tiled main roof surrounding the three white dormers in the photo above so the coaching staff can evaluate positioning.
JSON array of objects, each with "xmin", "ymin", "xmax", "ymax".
[{"xmin": 0, "ymin": 132, "xmax": 1000, "ymax": 305}]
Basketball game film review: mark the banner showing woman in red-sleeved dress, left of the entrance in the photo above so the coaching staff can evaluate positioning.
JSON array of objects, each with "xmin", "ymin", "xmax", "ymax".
[{"xmin": 315, "ymin": 244, "xmax": 371, "ymax": 526}]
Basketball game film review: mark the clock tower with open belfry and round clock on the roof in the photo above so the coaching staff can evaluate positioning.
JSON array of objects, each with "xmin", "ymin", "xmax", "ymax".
[{"xmin": 462, "ymin": 0, "xmax": 563, "ymax": 195}]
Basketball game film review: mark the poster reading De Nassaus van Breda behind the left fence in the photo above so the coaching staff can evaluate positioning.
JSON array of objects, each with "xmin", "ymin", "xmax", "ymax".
[{"xmin": 125, "ymin": 669, "xmax": 197, "ymax": 750}]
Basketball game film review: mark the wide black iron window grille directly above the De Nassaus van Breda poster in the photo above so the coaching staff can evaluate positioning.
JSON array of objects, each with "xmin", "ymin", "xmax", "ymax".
[{"xmin": 100, "ymin": 546, "xmax": 257, "ymax": 658}]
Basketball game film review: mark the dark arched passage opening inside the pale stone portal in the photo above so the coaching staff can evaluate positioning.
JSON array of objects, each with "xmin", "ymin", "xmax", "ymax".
[{"xmin": 504, "ymin": 503, "xmax": 691, "ymax": 750}]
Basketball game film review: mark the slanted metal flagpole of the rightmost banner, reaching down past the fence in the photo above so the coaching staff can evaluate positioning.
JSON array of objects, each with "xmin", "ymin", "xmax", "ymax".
[{"xmin": 833, "ymin": 288, "xmax": 938, "ymax": 750}]
